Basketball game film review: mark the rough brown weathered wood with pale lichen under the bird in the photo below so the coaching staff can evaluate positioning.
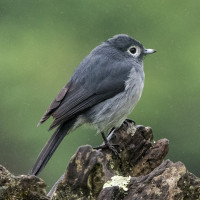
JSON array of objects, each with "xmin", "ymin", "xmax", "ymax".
[{"xmin": 0, "ymin": 121, "xmax": 200, "ymax": 200}]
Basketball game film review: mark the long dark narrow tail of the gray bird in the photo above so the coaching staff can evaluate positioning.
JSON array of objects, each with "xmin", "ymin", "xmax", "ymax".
[{"xmin": 29, "ymin": 119, "xmax": 76, "ymax": 175}]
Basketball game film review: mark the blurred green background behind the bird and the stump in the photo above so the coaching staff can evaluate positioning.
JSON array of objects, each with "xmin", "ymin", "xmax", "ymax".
[{"xmin": 0, "ymin": 0, "xmax": 200, "ymax": 190}]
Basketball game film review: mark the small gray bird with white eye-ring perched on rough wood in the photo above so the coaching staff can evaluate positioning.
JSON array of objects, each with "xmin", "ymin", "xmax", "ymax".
[{"xmin": 29, "ymin": 34, "xmax": 156, "ymax": 175}]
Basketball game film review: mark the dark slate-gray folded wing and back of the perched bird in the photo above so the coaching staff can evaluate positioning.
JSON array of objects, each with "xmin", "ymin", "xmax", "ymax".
[{"xmin": 40, "ymin": 47, "xmax": 132, "ymax": 130}]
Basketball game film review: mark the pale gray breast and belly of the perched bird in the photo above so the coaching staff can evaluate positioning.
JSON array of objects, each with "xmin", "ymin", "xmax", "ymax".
[{"xmin": 81, "ymin": 68, "xmax": 144, "ymax": 132}]
